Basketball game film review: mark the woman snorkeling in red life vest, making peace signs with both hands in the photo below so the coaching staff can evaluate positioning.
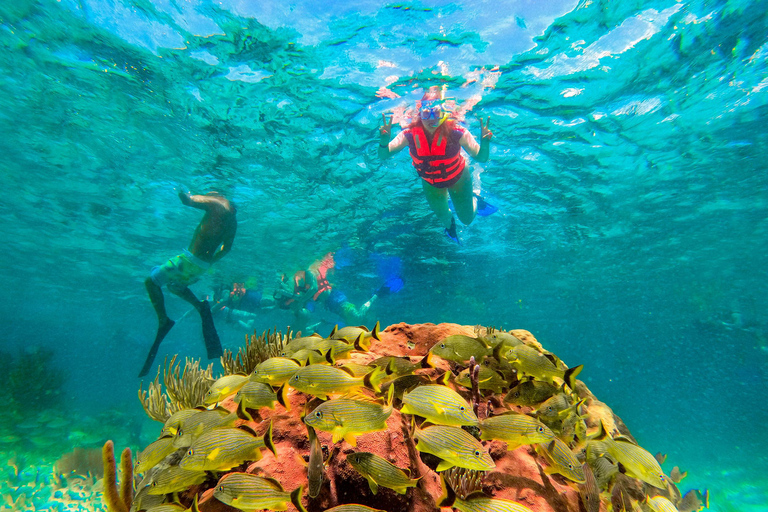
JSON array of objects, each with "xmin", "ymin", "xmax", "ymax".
[{"xmin": 379, "ymin": 86, "xmax": 496, "ymax": 243}]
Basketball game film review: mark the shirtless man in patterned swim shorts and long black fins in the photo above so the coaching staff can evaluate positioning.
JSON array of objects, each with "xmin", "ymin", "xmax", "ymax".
[{"xmin": 139, "ymin": 191, "xmax": 237, "ymax": 377}]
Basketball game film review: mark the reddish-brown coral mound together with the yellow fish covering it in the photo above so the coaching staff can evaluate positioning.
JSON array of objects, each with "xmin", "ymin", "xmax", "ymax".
[{"xmin": 124, "ymin": 323, "xmax": 705, "ymax": 512}]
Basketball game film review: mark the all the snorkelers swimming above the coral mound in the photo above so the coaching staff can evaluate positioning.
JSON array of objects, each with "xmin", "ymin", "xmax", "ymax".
[{"xmin": 139, "ymin": 86, "xmax": 496, "ymax": 377}]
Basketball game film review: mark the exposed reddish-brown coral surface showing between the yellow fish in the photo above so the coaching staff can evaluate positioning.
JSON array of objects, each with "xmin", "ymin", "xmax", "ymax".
[{"xmin": 124, "ymin": 323, "xmax": 704, "ymax": 512}]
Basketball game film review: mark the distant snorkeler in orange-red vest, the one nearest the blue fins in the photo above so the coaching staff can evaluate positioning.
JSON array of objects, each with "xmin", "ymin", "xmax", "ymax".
[{"xmin": 273, "ymin": 253, "xmax": 373, "ymax": 330}]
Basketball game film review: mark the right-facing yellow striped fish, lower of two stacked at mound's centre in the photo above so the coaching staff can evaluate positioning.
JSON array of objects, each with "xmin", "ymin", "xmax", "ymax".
[{"xmin": 413, "ymin": 425, "xmax": 496, "ymax": 472}]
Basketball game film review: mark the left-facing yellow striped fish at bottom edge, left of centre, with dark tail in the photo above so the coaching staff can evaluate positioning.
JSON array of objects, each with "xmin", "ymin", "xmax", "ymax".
[{"xmin": 213, "ymin": 473, "xmax": 306, "ymax": 512}]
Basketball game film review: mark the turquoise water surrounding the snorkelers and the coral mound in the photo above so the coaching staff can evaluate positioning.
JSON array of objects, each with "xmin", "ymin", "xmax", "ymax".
[{"xmin": 0, "ymin": 0, "xmax": 768, "ymax": 511}]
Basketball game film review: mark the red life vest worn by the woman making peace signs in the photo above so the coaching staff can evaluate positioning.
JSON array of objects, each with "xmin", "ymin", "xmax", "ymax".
[{"xmin": 405, "ymin": 124, "xmax": 467, "ymax": 188}]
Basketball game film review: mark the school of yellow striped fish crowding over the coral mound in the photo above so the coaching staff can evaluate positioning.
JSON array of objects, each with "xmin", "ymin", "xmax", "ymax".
[{"xmin": 126, "ymin": 323, "xmax": 708, "ymax": 512}]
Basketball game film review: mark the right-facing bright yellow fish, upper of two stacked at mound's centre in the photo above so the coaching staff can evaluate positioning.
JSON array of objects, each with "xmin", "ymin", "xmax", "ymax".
[{"xmin": 400, "ymin": 384, "xmax": 477, "ymax": 427}]
